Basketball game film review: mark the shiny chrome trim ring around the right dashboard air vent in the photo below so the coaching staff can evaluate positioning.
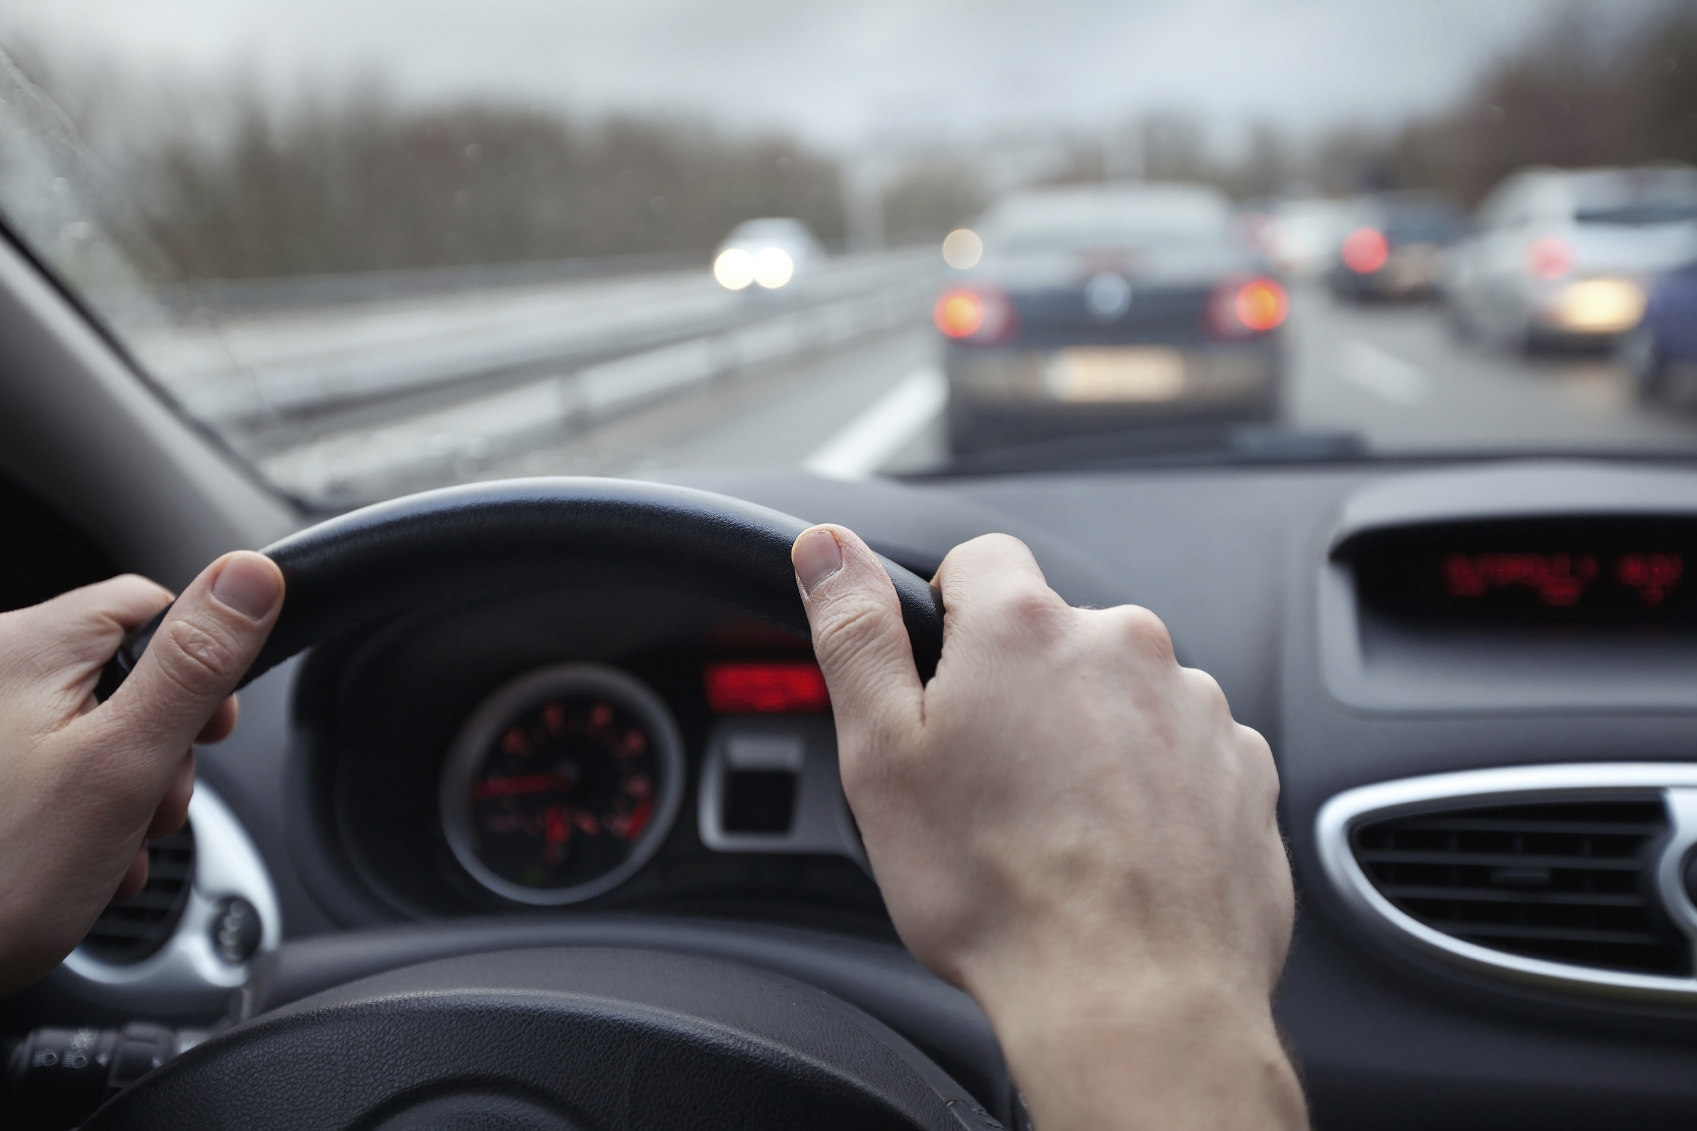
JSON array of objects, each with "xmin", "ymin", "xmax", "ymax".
[{"xmin": 1315, "ymin": 762, "xmax": 1697, "ymax": 1004}]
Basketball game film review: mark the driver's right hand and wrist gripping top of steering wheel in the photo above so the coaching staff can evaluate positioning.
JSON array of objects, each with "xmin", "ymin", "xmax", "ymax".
[{"xmin": 792, "ymin": 526, "xmax": 1305, "ymax": 1131}]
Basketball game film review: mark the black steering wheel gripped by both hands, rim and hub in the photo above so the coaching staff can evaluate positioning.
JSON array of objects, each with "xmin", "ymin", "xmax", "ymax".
[{"xmin": 83, "ymin": 479, "xmax": 1008, "ymax": 1131}]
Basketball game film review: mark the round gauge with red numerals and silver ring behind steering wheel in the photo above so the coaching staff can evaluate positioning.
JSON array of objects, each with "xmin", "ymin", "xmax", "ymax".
[{"xmin": 441, "ymin": 664, "xmax": 684, "ymax": 903}]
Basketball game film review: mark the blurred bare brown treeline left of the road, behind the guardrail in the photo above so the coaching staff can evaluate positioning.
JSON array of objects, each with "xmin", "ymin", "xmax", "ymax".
[{"xmin": 14, "ymin": 49, "xmax": 843, "ymax": 280}]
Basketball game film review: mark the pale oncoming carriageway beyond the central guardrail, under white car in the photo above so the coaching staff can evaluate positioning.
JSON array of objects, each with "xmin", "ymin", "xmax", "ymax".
[{"xmin": 132, "ymin": 251, "xmax": 938, "ymax": 431}]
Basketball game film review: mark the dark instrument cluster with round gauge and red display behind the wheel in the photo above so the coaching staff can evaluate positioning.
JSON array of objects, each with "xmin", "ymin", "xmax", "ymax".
[{"xmin": 297, "ymin": 593, "xmax": 891, "ymax": 936}]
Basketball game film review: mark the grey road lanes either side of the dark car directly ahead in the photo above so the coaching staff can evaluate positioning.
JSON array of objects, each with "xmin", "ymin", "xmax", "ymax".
[{"xmin": 458, "ymin": 280, "xmax": 1697, "ymax": 477}]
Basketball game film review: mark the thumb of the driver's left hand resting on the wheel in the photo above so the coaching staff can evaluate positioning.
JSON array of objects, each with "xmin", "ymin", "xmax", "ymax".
[{"xmin": 97, "ymin": 550, "xmax": 283, "ymax": 768}]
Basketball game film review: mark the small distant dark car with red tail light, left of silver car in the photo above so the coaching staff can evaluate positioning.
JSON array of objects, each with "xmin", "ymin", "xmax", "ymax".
[{"xmin": 1330, "ymin": 192, "xmax": 1468, "ymax": 301}]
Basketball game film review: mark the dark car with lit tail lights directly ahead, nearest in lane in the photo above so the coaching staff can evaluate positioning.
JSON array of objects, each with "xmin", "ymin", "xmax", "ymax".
[{"xmin": 933, "ymin": 185, "xmax": 1288, "ymax": 455}]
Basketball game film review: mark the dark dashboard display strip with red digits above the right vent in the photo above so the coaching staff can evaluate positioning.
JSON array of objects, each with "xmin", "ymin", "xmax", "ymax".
[{"xmin": 1336, "ymin": 516, "xmax": 1697, "ymax": 628}]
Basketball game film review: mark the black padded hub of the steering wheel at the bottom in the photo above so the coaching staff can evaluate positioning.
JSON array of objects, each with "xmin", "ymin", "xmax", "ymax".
[{"xmin": 83, "ymin": 948, "xmax": 1001, "ymax": 1131}]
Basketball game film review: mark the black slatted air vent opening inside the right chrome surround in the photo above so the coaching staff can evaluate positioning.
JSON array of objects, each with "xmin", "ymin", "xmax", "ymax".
[{"xmin": 1351, "ymin": 798, "xmax": 1692, "ymax": 975}]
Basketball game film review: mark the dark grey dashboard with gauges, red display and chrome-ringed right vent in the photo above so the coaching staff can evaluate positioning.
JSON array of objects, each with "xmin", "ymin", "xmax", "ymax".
[{"xmin": 16, "ymin": 460, "xmax": 1697, "ymax": 1128}]
